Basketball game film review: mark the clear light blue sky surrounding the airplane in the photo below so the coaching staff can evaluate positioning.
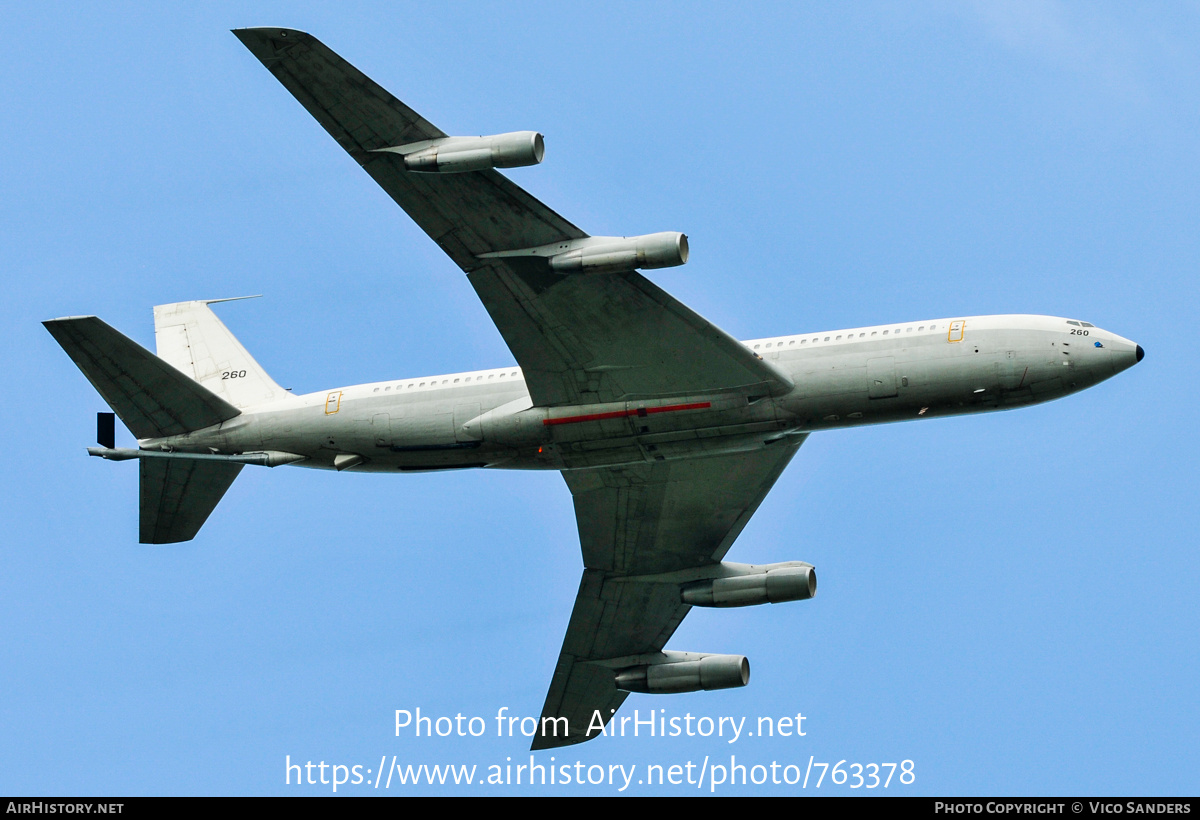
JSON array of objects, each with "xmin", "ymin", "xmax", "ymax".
[{"xmin": 0, "ymin": 4, "xmax": 1200, "ymax": 795}]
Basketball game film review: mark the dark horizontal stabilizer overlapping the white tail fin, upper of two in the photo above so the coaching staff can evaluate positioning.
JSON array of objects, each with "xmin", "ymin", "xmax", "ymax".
[{"xmin": 42, "ymin": 316, "xmax": 241, "ymax": 441}]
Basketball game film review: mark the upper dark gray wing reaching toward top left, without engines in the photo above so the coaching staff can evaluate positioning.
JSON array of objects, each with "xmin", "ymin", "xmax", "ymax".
[{"xmin": 234, "ymin": 29, "xmax": 791, "ymax": 406}]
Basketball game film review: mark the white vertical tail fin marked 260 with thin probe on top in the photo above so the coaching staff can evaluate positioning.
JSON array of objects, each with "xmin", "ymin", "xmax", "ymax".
[{"xmin": 154, "ymin": 297, "xmax": 292, "ymax": 409}]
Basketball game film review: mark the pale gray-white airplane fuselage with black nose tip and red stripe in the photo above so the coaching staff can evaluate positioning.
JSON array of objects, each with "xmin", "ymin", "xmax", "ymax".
[{"xmin": 152, "ymin": 316, "xmax": 1141, "ymax": 472}]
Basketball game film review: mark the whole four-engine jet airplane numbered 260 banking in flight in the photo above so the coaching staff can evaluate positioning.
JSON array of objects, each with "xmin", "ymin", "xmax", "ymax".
[{"xmin": 44, "ymin": 28, "xmax": 1145, "ymax": 750}]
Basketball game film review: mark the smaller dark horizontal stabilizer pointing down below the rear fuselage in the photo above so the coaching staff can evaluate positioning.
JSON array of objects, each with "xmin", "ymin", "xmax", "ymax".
[{"xmin": 138, "ymin": 459, "xmax": 242, "ymax": 544}]
